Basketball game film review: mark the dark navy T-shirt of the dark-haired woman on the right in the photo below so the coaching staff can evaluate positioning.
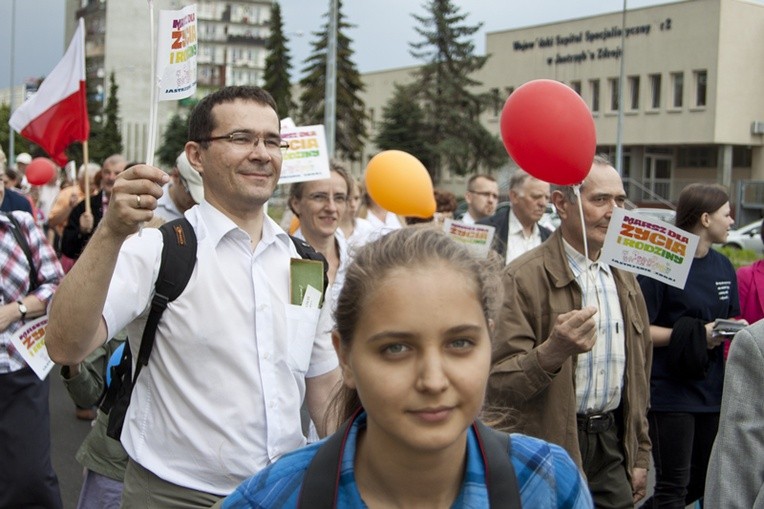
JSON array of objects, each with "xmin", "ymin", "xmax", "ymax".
[{"xmin": 637, "ymin": 249, "xmax": 740, "ymax": 412}]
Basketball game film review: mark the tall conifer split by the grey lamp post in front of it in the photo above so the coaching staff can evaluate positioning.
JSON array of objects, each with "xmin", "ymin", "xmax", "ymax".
[{"xmin": 299, "ymin": 0, "xmax": 367, "ymax": 161}]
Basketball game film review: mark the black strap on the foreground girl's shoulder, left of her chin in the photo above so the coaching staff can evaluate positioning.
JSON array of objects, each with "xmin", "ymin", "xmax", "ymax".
[{"xmin": 297, "ymin": 408, "xmax": 361, "ymax": 509}]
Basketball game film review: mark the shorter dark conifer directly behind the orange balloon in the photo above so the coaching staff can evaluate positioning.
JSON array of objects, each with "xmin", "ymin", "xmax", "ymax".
[{"xmin": 374, "ymin": 84, "xmax": 435, "ymax": 175}]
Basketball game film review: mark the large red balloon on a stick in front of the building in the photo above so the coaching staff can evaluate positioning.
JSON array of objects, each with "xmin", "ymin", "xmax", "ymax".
[{"xmin": 501, "ymin": 80, "xmax": 597, "ymax": 185}]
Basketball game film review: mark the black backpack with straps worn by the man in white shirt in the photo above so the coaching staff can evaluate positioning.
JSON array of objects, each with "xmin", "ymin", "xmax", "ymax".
[{"xmin": 100, "ymin": 217, "xmax": 329, "ymax": 440}]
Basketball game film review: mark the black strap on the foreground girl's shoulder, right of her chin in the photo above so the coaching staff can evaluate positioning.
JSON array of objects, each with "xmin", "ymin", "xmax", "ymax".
[{"xmin": 472, "ymin": 421, "xmax": 522, "ymax": 509}]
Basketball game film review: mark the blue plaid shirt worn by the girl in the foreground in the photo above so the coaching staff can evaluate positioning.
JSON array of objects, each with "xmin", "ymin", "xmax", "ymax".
[{"xmin": 222, "ymin": 413, "xmax": 593, "ymax": 509}]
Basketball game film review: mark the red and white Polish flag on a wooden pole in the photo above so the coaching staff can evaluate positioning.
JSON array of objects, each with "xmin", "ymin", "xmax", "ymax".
[{"xmin": 8, "ymin": 18, "xmax": 90, "ymax": 166}]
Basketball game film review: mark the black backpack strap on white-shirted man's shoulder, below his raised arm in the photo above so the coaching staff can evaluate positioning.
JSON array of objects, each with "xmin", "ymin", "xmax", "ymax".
[{"xmin": 133, "ymin": 217, "xmax": 196, "ymax": 384}]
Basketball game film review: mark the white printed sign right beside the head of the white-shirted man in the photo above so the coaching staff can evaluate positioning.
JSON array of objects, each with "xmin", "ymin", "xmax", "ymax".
[{"xmin": 279, "ymin": 125, "xmax": 329, "ymax": 184}]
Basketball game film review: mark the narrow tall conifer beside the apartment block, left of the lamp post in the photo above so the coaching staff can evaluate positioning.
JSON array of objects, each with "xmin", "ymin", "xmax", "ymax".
[{"xmin": 263, "ymin": 2, "xmax": 297, "ymax": 118}]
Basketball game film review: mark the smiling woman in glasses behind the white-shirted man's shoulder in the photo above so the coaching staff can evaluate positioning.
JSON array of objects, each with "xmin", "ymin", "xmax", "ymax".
[{"xmin": 289, "ymin": 163, "xmax": 352, "ymax": 295}]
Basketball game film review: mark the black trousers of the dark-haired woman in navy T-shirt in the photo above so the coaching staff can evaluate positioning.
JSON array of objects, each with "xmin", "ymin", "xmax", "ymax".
[{"xmin": 645, "ymin": 412, "xmax": 719, "ymax": 509}]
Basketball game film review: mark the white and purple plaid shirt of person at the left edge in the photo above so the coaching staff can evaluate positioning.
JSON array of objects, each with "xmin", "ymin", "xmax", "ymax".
[{"xmin": 0, "ymin": 210, "xmax": 64, "ymax": 374}]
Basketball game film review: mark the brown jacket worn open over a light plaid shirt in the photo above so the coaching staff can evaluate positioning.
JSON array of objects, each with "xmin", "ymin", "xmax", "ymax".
[{"xmin": 487, "ymin": 229, "xmax": 652, "ymax": 476}]
